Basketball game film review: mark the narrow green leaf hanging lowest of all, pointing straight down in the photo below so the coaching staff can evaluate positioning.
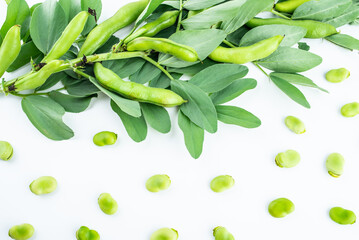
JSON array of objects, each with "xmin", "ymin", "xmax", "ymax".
[{"xmin": 178, "ymin": 111, "xmax": 204, "ymax": 159}]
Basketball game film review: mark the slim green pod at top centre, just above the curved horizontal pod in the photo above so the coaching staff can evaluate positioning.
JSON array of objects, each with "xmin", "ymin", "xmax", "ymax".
[{"xmin": 124, "ymin": 11, "xmax": 179, "ymax": 44}]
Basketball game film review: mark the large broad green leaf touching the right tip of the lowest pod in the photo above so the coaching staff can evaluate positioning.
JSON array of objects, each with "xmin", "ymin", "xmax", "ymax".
[{"xmin": 171, "ymin": 80, "xmax": 217, "ymax": 133}]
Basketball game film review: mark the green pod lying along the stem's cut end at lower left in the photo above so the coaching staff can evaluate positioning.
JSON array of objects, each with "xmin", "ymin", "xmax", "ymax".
[{"xmin": 8, "ymin": 60, "xmax": 64, "ymax": 92}]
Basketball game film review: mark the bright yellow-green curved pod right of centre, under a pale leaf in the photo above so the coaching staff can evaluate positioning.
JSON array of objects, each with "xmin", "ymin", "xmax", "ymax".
[{"xmin": 209, "ymin": 35, "xmax": 283, "ymax": 64}]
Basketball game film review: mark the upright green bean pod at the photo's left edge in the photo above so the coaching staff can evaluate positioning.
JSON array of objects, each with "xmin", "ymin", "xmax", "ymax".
[{"xmin": 0, "ymin": 25, "xmax": 21, "ymax": 77}]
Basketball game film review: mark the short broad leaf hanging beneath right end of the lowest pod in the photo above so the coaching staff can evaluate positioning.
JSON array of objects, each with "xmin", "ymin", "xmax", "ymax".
[{"xmin": 141, "ymin": 103, "xmax": 171, "ymax": 133}]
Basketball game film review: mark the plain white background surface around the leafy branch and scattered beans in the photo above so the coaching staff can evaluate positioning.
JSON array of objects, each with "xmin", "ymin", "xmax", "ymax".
[{"xmin": 0, "ymin": 0, "xmax": 359, "ymax": 240}]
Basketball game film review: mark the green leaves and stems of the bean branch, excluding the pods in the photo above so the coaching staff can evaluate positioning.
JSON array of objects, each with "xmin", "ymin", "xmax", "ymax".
[{"xmin": 0, "ymin": 0, "xmax": 359, "ymax": 158}]
